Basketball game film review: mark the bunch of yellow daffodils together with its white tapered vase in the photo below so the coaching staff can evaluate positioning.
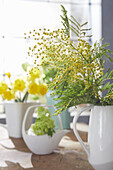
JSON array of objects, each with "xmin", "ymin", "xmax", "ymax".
[{"xmin": 0, "ymin": 67, "xmax": 48, "ymax": 138}]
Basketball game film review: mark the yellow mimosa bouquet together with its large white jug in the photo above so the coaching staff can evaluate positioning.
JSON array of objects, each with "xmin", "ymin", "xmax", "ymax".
[{"xmin": 25, "ymin": 5, "xmax": 113, "ymax": 170}]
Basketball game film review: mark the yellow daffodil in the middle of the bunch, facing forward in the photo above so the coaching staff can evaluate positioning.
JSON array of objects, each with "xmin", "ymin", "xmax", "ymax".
[{"xmin": 14, "ymin": 79, "xmax": 26, "ymax": 91}]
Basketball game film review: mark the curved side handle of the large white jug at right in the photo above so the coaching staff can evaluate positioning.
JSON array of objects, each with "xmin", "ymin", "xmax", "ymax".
[{"xmin": 73, "ymin": 106, "xmax": 93, "ymax": 157}]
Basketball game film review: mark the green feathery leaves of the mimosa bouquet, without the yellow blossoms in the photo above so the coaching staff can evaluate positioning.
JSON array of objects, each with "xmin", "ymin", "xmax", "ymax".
[{"xmin": 51, "ymin": 7, "xmax": 113, "ymax": 114}]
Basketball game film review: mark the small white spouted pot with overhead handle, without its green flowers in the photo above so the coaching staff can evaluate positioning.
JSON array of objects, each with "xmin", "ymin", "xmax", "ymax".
[{"xmin": 22, "ymin": 105, "xmax": 70, "ymax": 155}]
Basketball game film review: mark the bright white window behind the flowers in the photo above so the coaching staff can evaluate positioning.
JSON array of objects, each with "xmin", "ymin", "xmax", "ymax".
[{"xmin": 0, "ymin": 0, "xmax": 101, "ymax": 75}]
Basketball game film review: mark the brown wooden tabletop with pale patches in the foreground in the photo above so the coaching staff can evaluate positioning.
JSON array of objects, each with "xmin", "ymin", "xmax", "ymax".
[{"xmin": 0, "ymin": 127, "xmax": 93, "ymax": 170}]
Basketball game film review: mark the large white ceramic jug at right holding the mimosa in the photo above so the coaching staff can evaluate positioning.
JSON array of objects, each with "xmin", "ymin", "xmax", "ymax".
[{"xmin": 73, "ymin": 106, "xmax": 113, "ymax": 170}]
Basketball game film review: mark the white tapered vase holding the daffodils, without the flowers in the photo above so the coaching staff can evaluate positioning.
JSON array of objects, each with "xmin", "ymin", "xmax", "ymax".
[{"xmin": 4, "ymin": 102, "xmax": 36, "ymax": 138}]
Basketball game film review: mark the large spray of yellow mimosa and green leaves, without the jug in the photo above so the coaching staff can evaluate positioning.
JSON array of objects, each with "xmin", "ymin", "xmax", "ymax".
[{"xmin": 25, "ymin": 6, "xmax": 113, "ymax": 114}]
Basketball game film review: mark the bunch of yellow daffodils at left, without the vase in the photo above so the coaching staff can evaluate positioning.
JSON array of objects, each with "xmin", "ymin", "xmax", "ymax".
[{"xmin": 0, "ymin": 67, "xmax": 48, "ymax": 102}]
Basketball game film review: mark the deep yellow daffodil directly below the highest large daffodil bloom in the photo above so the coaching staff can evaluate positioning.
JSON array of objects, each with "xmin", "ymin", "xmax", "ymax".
[{"xmin": 28, "ymin": 82, "xmax": 39, "ymax": 94}]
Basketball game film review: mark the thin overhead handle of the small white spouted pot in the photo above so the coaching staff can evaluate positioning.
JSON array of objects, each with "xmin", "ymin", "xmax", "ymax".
[{"xmin": 22, "ymin": 104, "xmax": 63, "ymax": 134}]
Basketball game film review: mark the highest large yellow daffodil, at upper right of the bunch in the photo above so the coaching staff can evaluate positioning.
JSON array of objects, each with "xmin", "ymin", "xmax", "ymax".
[{"xmin": 28, "ymin": 67, "xmax": 41, "ymax": 81}]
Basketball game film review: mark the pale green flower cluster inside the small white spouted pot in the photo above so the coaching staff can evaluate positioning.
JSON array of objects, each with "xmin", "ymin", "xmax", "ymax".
[{"xmin": 31, "ymin": 107, "xmax": 55, "ymax": 136}]
